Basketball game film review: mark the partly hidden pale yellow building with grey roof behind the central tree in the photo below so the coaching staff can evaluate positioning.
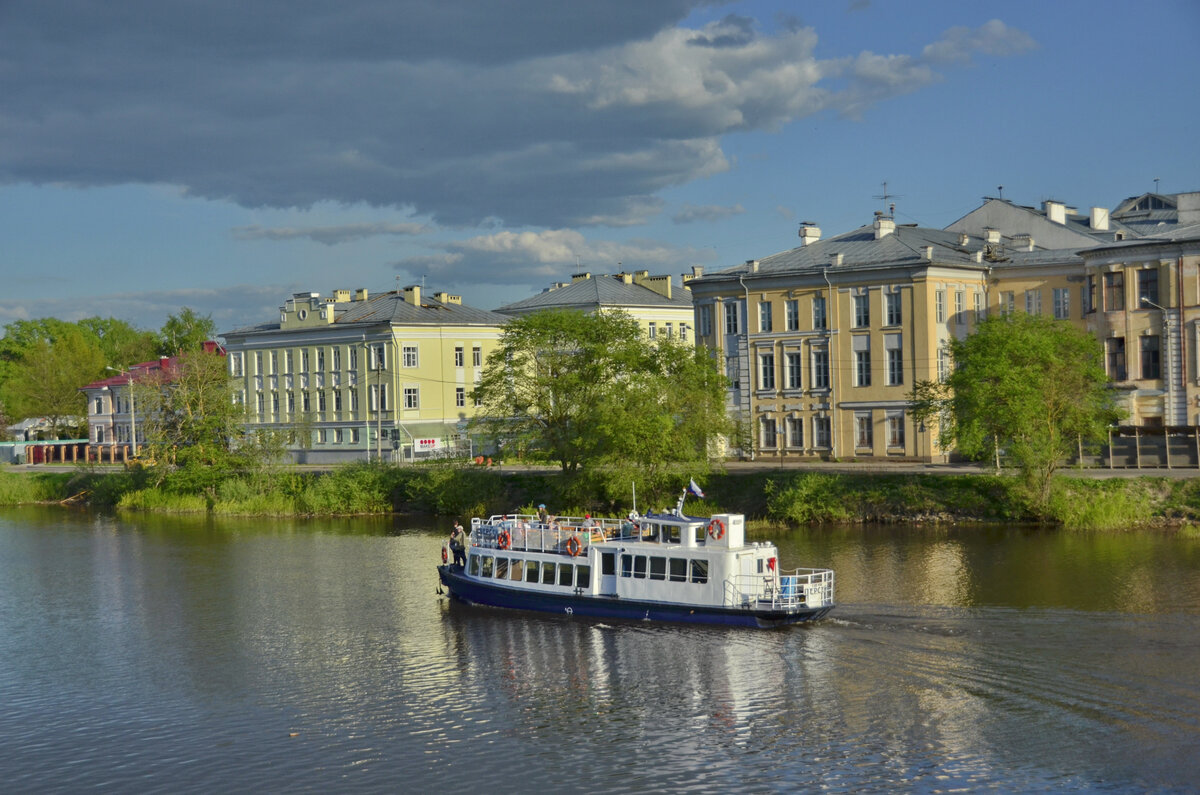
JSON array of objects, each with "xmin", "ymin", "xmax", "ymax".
[{"xmin": 496, "ymin": 270, "xmax": 694, "ymax": 341}]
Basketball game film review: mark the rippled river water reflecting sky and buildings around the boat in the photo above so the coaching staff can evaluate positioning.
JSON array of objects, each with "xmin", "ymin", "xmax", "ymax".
[{"xmin": 0, "ymin": 509, "xmax": 1200, "ymax": 793}]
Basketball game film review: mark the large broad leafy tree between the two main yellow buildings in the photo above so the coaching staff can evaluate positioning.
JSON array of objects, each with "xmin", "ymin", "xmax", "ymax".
[{"xmin": 474, "ymin": 311, "xmax": 724, "ymax": 472}]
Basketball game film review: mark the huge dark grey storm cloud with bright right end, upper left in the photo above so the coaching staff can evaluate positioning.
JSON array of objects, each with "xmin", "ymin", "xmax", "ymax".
[{"xmin": 0, "ymin": 0, "xmax": 1024, "ymax": 227}]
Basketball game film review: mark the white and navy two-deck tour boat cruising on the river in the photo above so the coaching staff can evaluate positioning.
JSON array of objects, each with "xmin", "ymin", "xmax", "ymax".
[{"xmin": 438, "ymin": 500, "xmax": 834, "ymax": 627}]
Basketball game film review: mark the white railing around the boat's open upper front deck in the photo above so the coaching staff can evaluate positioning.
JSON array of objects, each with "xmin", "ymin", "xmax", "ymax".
[{"xmin": 470, "ymin": 514, "xmax": 637, "ymax": 555}]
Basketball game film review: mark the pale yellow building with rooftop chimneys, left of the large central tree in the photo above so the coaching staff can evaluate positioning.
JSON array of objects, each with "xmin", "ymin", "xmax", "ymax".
[{"xmin": 223, "ymin": 286, "xmax": 508, "ymax": 462}]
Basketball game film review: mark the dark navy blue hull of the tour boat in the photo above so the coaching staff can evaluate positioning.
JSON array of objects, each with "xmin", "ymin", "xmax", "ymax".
[{"xmin": 438, "ymin": 566, "xmax": 833, "ymax": 628}]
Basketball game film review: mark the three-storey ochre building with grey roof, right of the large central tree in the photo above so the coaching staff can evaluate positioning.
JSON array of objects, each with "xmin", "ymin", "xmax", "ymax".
[{"xmin": 690, "ymin": 215, "xmax": 990, "ymax": 460}]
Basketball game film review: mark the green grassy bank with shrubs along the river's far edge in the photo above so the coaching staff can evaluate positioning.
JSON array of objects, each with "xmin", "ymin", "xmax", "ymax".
[{"xmin": 0, "ymin": 464, "xmax": 1200, "ymax": 530}]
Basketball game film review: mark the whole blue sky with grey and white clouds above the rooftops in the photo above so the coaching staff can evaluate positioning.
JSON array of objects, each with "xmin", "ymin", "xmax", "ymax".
[{"xmin": 0, "ymin": 0, "xmax": 1200, "ymax": 331}]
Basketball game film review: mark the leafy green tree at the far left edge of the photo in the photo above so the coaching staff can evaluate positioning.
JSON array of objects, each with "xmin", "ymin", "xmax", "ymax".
[{"xmin": 4, "ymin": 325, "xmax": 104, "ymax": 436}]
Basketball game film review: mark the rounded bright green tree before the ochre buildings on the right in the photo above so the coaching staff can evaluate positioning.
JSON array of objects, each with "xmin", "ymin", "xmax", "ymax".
[{"xmin": 908, "ymin": 315, "xmax": 1121, "ymax": 509}]
